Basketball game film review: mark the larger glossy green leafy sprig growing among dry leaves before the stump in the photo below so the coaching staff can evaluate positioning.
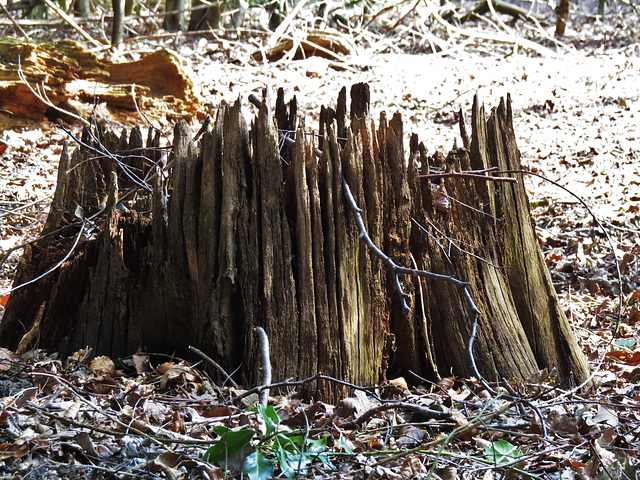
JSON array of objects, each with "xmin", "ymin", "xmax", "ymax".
[{"xmin": 203, "ymin": 406, "xmax": 334, "ymax": 480}]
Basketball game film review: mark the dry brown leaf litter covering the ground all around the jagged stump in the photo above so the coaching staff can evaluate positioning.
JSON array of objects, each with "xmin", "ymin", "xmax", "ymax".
[{"xmin": 0, "ymin": 0, "xmax": 640, "ymax": 480}]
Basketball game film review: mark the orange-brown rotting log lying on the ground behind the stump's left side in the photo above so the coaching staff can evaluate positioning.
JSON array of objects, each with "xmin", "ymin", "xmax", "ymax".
[{"xmin": 0, "ymin": 37, "xmax": 200, "ymax": 122}]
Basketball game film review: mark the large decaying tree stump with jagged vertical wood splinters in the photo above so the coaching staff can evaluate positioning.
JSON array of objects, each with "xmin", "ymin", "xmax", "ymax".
[{"xmin": 0, "ymin": 84, "xmax": 588, "ymax": 399}]
